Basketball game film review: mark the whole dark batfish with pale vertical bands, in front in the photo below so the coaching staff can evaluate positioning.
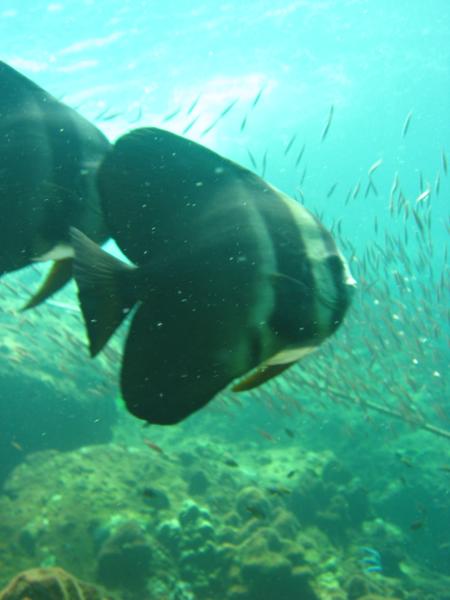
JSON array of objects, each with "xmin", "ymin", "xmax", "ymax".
[{"xmin": 72, "ymin": 128, "xmax": 354, "ymax": 424}]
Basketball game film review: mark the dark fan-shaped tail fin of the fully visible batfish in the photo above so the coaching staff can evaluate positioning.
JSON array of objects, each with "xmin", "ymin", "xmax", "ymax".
[{"xmin": 70, "ymin": 227, "xmax": 138, "ymax": 356}]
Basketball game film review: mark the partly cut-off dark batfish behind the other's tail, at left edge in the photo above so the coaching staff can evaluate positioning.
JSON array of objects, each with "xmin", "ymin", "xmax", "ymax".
[{"xmin": 0, "ymin": 62, "xmax": 110, "ymax": 307}]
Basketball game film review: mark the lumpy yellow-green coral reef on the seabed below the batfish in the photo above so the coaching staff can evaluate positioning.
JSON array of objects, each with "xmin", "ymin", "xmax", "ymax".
[{"xmin": 0, "ymin": 434, "xmax": 450, "ymax": 600}]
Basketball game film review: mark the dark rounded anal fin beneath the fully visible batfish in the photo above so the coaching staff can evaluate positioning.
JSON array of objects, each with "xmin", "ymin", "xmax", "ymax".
[{"xmin": 120, "ymin": 302, "xmax": 239, "ymax": 425}]
